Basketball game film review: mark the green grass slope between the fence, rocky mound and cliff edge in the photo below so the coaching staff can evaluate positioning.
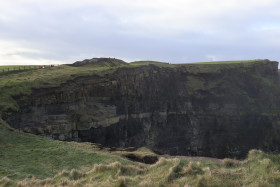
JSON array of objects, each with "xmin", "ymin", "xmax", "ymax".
[{"xmin": 0, "ymin": 64, "xmax": 126, "ymax": 115}]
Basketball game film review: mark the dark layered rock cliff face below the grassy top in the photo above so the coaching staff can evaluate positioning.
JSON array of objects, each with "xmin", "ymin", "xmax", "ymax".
[{"xmin": 6, "ymin": 61, "xmax": 280, "ymax": 158}]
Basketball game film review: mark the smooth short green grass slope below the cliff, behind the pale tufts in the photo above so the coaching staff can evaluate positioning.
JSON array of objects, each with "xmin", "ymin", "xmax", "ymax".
[{"xmin": 0, "ymin": 121, "xmax": 133, "ymax": 181}]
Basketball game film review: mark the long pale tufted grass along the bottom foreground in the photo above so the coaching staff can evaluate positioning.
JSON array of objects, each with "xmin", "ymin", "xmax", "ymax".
[{"xmin": 0, "ymin": 150, "xmax": 280, "ymax": 187}]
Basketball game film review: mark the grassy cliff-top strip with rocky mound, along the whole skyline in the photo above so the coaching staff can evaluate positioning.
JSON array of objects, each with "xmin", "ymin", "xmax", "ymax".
[{"xmin": 0, "ymin": 58, "xmax": 278, "ymax": 115}]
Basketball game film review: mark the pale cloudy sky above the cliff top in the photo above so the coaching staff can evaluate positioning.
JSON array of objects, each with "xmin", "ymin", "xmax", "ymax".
[{"xmin": 0, "ymin": 0, "xmax": 280, "ymax": 65}]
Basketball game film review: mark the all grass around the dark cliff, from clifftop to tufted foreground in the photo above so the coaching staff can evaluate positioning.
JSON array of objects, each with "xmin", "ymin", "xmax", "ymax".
[{"xmin": 0, "ymin": 61, "xmax": 280, "ymax": 186}]
